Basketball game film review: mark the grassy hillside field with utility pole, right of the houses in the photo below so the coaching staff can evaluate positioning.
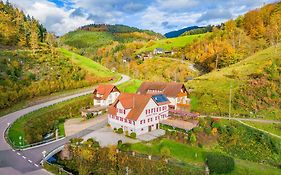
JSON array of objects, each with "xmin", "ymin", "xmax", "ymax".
[{"xmin": 186, "ymin": 45, "xmax": 281, "ymax": 119}]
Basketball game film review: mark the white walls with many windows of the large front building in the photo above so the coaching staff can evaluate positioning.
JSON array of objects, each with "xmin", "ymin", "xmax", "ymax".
[{"xmin": 108, "ymin": 99, "xmax": 168, "ymax": 135}]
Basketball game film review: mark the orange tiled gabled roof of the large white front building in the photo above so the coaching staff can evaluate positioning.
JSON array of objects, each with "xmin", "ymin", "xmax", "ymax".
[{"xmin": 108, "ymin": 93, "xmax": 170, "ymax": 121}]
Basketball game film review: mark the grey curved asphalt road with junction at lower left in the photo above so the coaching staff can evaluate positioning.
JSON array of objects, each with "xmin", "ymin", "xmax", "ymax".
[{"xmin": 0, "ymin": 75, "xmax": 130, "ymax": 175}]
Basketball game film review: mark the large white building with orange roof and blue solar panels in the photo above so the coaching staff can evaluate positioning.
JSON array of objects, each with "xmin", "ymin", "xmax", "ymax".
[{"xmin": 108, "ymin": 93, "xmax": 170, "ymax": 135}]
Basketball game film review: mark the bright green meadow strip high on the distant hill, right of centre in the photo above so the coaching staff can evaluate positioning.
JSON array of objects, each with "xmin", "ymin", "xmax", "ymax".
[{"xmin": 137, "ymin": 34, "xmax": 205, "ymax": 53}]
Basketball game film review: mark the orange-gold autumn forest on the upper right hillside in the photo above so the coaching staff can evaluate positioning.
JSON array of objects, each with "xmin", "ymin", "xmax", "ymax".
[{"xmin": 183, "ymin": 2, "xmax": 281, "ymax": 71}]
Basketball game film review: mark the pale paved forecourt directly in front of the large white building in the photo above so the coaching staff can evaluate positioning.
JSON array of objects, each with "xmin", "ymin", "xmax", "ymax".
[{"xmin": 83, "ymin": 127, "xmax": 139, "ymax": 147}]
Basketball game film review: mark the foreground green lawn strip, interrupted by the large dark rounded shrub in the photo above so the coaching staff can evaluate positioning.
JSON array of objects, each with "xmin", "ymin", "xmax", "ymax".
[{"xmin": 131, "ymin": 139, "xmax": 281, "ymax": 175}]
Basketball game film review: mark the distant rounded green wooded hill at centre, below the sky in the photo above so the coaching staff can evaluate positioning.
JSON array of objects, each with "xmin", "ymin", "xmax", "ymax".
[{"xmin": 60, "ymin": 24, "xmax": 163, "ymax": 61}]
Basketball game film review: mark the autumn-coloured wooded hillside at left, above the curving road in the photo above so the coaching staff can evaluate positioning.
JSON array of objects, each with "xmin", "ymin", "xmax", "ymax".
[{"xmin": 0, "ymin": 2, "xmax": 114, "ymax": 110}]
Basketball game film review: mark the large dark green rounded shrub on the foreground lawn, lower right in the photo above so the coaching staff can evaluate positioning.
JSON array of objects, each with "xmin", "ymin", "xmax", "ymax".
[{"xmin": 203, "ymin": 153, "xmax": 235, "ymax": 174}]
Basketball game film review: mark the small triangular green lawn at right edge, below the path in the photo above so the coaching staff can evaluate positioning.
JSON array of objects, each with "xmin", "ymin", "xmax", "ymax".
[{"xmin": 243, "ymin": 121, "xmax": 281, "ymax": 136}]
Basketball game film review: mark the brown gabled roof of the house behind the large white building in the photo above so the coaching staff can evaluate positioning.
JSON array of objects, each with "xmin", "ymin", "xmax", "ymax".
[{"xmin": 137, "ymin": 82, "xmax": 188, "ymax": 97}]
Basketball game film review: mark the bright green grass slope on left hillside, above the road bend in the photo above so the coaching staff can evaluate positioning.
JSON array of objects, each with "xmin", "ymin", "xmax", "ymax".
[{"xmin": 61, "ymin": 48, "xmax": 116, "ymax": 77}]
